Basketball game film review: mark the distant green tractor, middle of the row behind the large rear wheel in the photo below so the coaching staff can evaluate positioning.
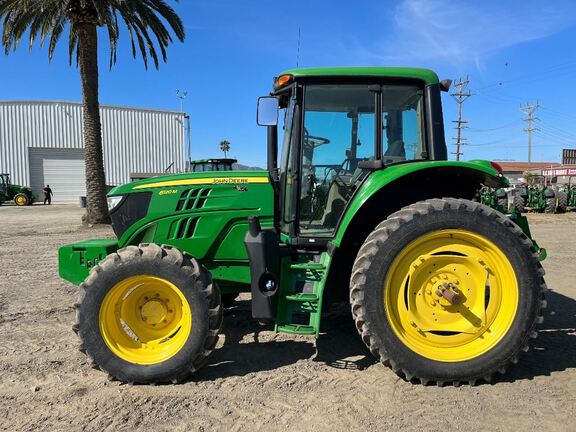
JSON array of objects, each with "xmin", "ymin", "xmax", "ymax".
[{"xmin": 512, "ymin": 175, "xmax": 556, "ymax": 213}]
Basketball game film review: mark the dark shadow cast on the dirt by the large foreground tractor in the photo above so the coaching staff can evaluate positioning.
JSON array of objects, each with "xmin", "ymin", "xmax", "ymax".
[{"xmin": 193, "ymin": 292, "xmax": 576, "ymax": 382}]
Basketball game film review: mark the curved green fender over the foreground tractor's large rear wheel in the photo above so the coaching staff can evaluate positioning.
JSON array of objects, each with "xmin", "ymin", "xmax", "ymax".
[{"xmin": 332, "ymin": 160, "xmax": 509, "ymax": 247}]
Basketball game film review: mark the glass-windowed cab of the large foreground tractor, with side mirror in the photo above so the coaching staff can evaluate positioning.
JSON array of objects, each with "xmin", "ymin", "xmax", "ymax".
[{"xmin": 258, "ymin": 68, "xmax": 449, "ymax": 246}]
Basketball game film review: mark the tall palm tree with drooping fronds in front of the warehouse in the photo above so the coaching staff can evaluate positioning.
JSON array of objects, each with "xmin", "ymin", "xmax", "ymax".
[{"xmin": 0, "ymin": 0, "xmax": 184, "ymax": 224}]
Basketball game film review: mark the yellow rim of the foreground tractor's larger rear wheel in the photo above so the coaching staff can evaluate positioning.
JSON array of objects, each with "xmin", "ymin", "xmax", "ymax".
[{"xmin": 384, "ymin": 229, "xmax": 519, "ymax": 362}]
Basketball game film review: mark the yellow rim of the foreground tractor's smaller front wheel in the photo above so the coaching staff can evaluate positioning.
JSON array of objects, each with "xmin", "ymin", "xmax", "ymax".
[{"xmin": 99, "ymin": 275, "xmax": 192, "ymax": 365}]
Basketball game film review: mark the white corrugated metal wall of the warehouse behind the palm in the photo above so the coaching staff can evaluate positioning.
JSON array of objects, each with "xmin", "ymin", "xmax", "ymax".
[{"xmin": 0, "ymin": 101, "xmax": 186, "ymax": 185}]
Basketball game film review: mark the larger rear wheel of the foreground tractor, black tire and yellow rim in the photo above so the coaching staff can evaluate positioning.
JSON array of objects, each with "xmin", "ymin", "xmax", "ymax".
[{"xmin": 350, "ymin": 198, "xmax": 546, "ymax": 385}]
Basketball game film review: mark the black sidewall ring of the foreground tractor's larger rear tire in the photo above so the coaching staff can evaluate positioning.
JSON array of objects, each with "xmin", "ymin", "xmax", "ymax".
[{"xmin": 363, "ymin": 204, "xmax": 540, "ymax": 381}]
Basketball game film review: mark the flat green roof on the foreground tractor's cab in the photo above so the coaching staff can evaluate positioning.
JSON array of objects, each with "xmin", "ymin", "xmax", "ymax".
[{"xmin": 279, "ymin": 66, "xmax": 439, "ymax": 84}]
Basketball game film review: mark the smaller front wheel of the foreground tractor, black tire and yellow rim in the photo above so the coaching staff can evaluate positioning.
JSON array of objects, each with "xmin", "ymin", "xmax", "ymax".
[{"xmin": 73, "ymin": 244, "xmax": 222, "ymax": 384}]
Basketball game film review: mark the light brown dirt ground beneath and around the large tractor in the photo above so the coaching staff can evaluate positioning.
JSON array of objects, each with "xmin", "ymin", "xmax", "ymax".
[{"xmin": 0, "ymin": 205, "xmax": 576, "ymax": 432}]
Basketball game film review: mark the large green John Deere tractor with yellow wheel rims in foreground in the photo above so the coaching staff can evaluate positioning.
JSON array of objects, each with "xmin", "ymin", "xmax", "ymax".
[{"xmin": 59, "ymin": 67, "xmax": 546, "ymax": 385}]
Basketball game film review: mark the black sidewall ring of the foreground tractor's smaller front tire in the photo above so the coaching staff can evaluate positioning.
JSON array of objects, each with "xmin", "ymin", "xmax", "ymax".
[{"xmin": 79, "ymin": 257, "xmax": 209, "ymax": 382}]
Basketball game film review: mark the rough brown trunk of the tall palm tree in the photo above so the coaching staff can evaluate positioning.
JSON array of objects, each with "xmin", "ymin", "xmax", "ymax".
[{"xmin": 76, "ymin": 22, "xmax": 110, "ymax": 224}]
